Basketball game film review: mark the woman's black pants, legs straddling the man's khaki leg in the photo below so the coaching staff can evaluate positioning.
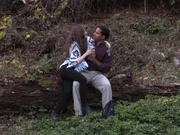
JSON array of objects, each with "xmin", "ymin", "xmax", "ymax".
[{"xmin": 55, "ymin": 65, "xmax": 87, "ymax": 113}]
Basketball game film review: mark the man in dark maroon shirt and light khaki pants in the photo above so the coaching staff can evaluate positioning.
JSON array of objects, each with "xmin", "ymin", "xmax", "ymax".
[{"xmin": 73, "ymin": 26, "xmax": 112, "ymax": 116}]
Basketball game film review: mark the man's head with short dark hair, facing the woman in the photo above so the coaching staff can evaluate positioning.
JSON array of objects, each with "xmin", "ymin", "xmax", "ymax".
[{"xmin": 93, "ymin": 25, "xmax": 110, "ymax": 43}]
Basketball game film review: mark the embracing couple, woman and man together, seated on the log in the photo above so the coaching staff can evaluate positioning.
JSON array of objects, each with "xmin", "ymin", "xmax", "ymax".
[{"xmin": 52, "ymin": 26, "xmax": 112, "ymax": 118}]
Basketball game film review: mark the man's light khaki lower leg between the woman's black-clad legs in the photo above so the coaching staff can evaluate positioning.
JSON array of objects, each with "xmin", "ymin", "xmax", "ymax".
[{"xmin": 73, "ymin": 81, "xmax": 83, "ymax": 116}]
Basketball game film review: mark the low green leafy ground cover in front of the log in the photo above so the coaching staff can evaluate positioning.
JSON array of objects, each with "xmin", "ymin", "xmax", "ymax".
[{"xmin": 0, "ymin": 96, "xmax": 180, "ymax": 135}]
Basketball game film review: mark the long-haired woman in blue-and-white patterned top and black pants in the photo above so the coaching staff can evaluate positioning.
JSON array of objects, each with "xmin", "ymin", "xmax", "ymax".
[{"xmin": 52, "ymin": 26, "xmax": 94, "ymax": 117}]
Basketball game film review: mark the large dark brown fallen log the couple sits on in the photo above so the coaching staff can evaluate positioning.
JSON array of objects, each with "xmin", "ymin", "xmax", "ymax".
[{"xmin": 0, "ymin": 74, "xmax": 180, "ymax": 115}]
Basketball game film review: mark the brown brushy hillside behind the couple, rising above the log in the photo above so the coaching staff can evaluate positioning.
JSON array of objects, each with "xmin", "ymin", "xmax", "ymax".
[{"xmin": 0, "ymin": 4, "xmax": 180, "ymax": 131}]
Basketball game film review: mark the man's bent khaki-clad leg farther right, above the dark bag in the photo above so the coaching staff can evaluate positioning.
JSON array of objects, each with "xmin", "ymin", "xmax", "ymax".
[{"xmin": 90, "ymin": 72, "xmax": 112, "ymax": 108}]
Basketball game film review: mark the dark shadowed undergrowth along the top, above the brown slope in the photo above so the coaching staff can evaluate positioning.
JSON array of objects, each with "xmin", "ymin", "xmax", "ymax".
[{"xmin": 0, "ymin": 0, "xmax": 180, "ymax": 20}]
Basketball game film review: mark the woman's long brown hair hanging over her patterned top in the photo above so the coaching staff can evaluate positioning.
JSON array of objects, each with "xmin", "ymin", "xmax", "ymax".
[{"xmin": 65, "ymin": 26, "xmax": 87, "ymax": 58}]
